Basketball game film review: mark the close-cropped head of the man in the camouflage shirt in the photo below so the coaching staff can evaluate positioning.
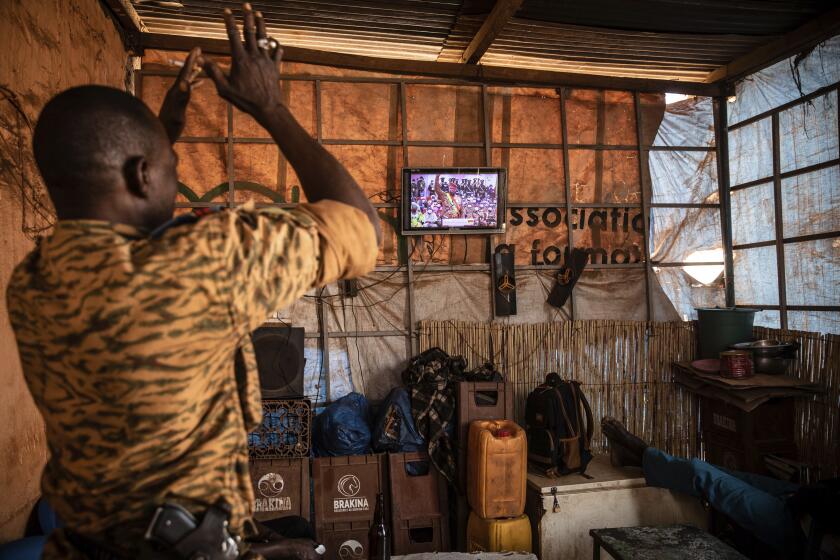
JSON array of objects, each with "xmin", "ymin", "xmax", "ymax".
[{"xmin": 32, "ymin": 86, "xmax": 177, "ymax": 228}]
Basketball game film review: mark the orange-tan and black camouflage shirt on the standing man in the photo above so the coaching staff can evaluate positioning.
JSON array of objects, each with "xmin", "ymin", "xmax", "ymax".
[{"xmin": 7, "ymin": 201, "xmax": 377, "ymax": 558}]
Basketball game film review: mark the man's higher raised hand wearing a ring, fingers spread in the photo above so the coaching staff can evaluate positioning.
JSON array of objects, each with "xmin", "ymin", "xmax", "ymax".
[{"xmin": 204, "ymin": 4, "xmax": 283, "ymax": 125}]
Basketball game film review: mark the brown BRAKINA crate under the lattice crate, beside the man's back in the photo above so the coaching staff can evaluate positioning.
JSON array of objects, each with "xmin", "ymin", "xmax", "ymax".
[{"xmin": 248, "ymin": 458, "xmax": 310, "ymax": 521}]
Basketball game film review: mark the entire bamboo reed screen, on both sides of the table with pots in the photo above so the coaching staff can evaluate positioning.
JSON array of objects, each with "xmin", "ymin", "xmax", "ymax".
[{"xmin": 420, "ymin": 321, "xmax": 840, "ymax": 477}]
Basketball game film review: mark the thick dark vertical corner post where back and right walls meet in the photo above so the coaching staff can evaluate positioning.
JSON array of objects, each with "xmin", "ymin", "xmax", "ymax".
[{"xmin": 714, "ymin": 97, "xmax": 735, "ymax": 307}]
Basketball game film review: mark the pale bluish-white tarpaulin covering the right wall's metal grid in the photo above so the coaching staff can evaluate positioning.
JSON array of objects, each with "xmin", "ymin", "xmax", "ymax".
[{"xmin": 729, "ymin": 37, "xmax": 840, "ymax": 333}]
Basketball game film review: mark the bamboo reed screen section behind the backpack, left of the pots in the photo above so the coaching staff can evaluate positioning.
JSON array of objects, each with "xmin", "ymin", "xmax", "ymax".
[{"xmin": 420, "ymin": 321, "xmax": 700, "ymax": 456}]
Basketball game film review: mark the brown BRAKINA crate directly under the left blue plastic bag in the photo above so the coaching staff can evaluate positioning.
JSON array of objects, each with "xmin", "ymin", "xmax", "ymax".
[{"xmin": 312, "ymin": 454, "xmax": 390, "ymax": 525}]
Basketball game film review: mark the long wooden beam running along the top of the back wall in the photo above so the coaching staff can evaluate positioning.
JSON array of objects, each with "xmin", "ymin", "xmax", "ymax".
[{"xmin": 140, "ymin": 33, "xmax": 723, "ymax": 97}]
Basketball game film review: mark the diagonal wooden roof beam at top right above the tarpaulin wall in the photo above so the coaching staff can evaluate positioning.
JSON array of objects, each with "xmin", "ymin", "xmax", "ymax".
[{"xmin": 705, "ymin": 8, "xmax": 840, "ymax": 84}]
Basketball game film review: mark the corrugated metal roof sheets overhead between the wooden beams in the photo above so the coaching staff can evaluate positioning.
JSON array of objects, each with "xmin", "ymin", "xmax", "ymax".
[{"xmin": 131, "ymin": 0, "xmax": 834, "ymax": 81}]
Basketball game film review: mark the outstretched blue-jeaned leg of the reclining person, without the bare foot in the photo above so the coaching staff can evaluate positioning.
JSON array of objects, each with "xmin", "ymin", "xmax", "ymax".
[{"xmin": 642, "ymin": 447, "xmax": 799, "ymax": 550}]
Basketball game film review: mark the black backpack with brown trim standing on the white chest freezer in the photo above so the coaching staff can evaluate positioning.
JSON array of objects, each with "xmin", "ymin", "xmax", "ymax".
[{"xmin": 525, "ymin": 373, "xmax": 594, "ymax": 477}]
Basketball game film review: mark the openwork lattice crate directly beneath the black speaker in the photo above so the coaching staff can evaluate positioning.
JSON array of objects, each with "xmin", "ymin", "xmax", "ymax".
[{"xmin": 248, "ymin": 399, "xmax": 312, "ymax": 459}]
